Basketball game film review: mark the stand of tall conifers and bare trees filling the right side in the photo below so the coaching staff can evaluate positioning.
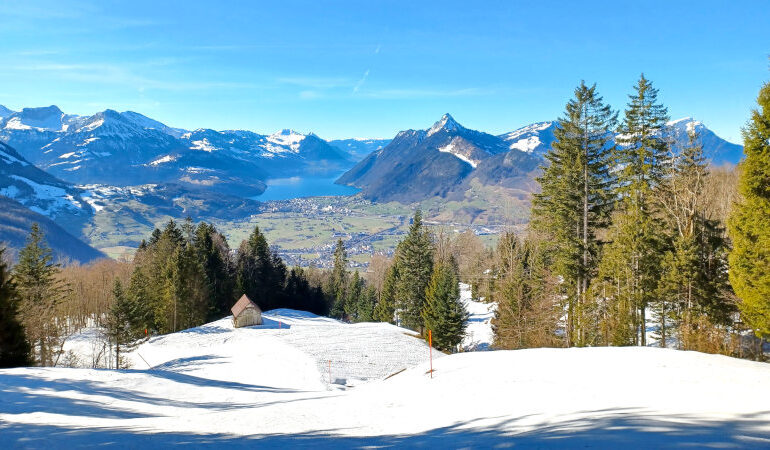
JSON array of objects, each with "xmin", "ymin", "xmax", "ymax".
[{"xmin": 491, "ymin": 76, "xmax": 770, "ymax": 355}]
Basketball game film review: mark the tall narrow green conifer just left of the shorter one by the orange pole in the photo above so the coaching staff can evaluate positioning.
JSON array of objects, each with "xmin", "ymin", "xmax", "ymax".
[{"xmin": 395, "ymin": 210, "xmax": 434, "ymax": 332}]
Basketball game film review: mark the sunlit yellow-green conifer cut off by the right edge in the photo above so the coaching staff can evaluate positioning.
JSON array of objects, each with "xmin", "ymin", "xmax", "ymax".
[{"xmin": 728, "ymin": 79, "xmax": 770, "ymax": 339}]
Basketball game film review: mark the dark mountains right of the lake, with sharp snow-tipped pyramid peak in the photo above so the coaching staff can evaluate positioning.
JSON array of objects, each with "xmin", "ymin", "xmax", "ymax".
[{"xmin": 337, "ymin": 114, "xmax": 743, "ymax": 203}]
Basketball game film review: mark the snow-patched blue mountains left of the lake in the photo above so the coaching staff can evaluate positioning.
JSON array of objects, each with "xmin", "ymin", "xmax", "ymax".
[{"xmin": 0, "ymin": 106, "xmax": 353, "ymax": 197}]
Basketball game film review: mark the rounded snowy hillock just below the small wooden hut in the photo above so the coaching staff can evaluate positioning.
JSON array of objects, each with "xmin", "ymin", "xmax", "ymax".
[{"xmin": 131, "ymin": 309, "xmax": 439, "ymax": 389}]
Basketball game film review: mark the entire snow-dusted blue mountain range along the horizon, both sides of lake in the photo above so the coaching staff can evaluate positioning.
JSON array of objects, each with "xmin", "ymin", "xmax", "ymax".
[{"xmin": 0, "ymin": 106, "xmax": 742, "ymax": 259}]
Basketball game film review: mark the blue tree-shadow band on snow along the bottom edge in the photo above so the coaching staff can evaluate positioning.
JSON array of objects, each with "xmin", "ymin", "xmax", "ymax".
[{"xmin": 0, "ymin": 410, "xmax": 770, "ymax": 449}]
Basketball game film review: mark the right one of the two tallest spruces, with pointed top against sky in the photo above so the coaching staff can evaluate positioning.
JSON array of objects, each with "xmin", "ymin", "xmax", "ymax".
[{"xmin": 594, "ymin": 75, "xmax": 669, "ymax": 345}]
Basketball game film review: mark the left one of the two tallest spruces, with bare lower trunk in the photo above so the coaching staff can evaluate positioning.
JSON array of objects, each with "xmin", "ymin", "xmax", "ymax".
[{"xmin": 532, "ymin": 81, "xmax": 617, "ymax": 345}]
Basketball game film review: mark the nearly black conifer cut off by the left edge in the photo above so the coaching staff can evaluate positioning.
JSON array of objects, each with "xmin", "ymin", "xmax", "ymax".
[{"xmin": 0, "ymin": 247, "xmax": 31, "ymax": 369}]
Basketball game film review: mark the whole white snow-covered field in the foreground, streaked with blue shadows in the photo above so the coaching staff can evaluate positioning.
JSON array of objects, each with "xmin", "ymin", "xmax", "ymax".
[{"xmin": 0, "ymin": 310, "xmax": 770, "ymax": 448}]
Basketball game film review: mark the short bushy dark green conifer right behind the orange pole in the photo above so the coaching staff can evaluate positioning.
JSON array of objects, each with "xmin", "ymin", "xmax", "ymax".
[{"xmin": 422, "ymin": 262, "xmax": 468, "ymax": 351}]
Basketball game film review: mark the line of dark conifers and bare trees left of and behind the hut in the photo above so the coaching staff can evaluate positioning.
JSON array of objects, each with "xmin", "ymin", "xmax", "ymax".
[{"xmin": 0, "ymin": 219, "xmax": 332, "ymax": 367}]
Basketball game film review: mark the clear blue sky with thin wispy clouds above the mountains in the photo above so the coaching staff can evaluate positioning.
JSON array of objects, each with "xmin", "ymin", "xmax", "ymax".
[{"xmin": 0, "ymin": 0, "xmax": 770, "ymax": 142}]
